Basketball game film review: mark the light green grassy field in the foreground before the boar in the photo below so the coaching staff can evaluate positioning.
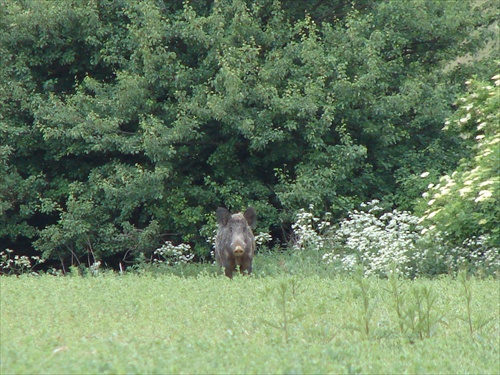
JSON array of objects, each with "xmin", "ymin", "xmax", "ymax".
[{"xmin": 0, "ymin": 274, "xmax": 500, "ymax": 374}]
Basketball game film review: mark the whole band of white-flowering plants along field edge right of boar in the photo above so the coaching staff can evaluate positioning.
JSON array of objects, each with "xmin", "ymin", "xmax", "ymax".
[{"xmin": 292, "ymin": 200, "xmax": 500, "ymax": 277}]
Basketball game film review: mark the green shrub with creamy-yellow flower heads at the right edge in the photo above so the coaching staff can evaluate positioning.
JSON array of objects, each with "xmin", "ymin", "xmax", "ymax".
[{"xmin": 421, "ymin": 74, "xmax": 500, "ymax": 247}]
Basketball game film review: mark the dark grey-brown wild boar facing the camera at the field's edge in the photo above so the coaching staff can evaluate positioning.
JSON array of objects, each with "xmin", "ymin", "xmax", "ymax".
[{"xmin": 215, "ymin": 207, "xmax": 256, "ymax": 278}]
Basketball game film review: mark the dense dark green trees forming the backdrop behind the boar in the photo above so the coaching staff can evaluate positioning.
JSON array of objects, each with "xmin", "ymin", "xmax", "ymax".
[{"xmin": 0, "ymin": 0, "xmax": 496, "ymax": 264}]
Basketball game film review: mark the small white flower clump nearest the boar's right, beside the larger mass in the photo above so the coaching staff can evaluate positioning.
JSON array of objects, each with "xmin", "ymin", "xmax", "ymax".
[{"xmin": 292, "ymin": 206, "xmax": 331, "ymax": 251}]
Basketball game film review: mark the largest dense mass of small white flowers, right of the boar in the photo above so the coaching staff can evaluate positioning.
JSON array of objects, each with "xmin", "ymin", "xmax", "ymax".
[{"xmin": 323, "ymin": 200, "xmax": 421, "ymax": 276}]
